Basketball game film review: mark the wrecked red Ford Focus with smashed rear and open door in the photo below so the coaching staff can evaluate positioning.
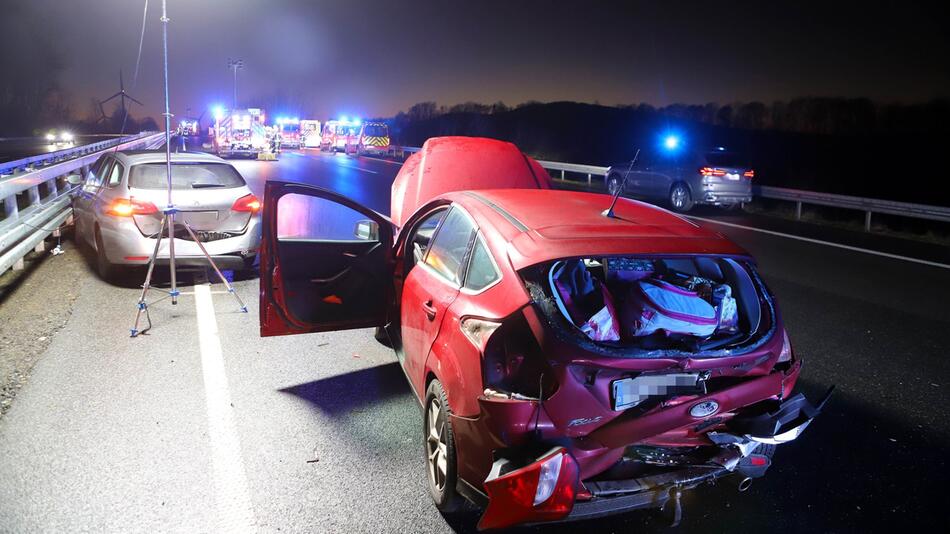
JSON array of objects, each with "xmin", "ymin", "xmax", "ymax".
[{"xmin": 260, "ymin": 137, "xmax": 830, "ymax": 529}]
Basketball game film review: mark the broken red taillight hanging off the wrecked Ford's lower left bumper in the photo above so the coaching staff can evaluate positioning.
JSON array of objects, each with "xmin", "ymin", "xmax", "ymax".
[{"xmin": 478, "ymin": 447, "xmax": 579, "ymax": 530}]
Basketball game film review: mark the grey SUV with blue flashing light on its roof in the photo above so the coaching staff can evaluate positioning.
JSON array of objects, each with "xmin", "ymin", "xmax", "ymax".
[{"xmin": 605, "ymin": 148, "xmax": 755, "ymax": 212}]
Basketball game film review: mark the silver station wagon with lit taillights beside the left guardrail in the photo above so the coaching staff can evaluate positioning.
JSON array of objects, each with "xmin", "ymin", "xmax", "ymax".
[{"xmin": 73, "ymin": 151, "xmax": 261, "ymax": 279}]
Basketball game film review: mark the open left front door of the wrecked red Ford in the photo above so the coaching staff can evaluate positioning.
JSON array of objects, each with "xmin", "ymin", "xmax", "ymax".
[{"xmin": 260, "ymin": 182, "xmax": 393, "ymax": 336}]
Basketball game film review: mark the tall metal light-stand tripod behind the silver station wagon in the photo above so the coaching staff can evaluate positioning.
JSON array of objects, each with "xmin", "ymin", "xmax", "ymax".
[{"xmin": 131, "ymin": 0, "xmax": 247, "ymax": 337}]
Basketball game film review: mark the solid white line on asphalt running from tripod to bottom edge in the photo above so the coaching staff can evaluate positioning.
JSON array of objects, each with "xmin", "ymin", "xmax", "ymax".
[{"xmin": 195, "ymin": 284, "xmax": 254, "ymax": 532}]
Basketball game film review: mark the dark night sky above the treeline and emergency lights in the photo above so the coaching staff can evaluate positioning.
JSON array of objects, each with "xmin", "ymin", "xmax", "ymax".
[{"xmin": 0, "ymin": 0, "xmax": 950, "ymax": 118}]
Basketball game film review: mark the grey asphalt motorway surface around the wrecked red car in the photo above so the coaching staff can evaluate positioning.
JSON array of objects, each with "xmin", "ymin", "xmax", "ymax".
[{"xmin": 0, "ymin": 140, "xmax": 950, "ymax": 533}]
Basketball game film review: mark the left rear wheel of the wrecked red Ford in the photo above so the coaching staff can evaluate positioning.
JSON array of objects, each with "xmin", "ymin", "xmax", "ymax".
[{"xmin": 422, "ymin": 380, "xmax": 463, "ymax": 514}]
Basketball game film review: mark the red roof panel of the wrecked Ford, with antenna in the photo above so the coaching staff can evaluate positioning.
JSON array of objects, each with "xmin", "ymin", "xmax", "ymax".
[{"xmin": 447, "ymin": 189, "xmax": 746, "ymax": 269}]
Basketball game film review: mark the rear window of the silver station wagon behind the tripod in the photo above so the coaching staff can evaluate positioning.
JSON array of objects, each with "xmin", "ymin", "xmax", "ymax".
[{"xmin": 129, "ymin": 163, "xmax": 246, "ymax": 189}]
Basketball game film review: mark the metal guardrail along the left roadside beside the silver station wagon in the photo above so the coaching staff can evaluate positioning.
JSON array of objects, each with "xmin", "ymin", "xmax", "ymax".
[{"xmin": 0, "ymin": 132, "xmax": 165, "ymax": 274}]
